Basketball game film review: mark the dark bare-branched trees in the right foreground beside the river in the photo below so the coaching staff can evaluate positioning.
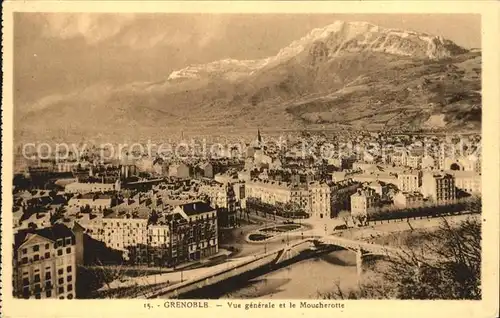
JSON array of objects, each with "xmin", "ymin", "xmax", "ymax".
[{"xmin": 322, "ymin": 218, "xmax": 481, "ymax": 300}]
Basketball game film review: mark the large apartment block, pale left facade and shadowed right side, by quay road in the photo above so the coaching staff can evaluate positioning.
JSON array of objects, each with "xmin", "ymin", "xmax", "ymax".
[{"xmin": 82, "ymin": 201, "xmax": 218, "ymax": 266}]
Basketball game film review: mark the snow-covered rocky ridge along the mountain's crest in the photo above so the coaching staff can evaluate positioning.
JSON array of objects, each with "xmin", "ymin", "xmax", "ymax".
[{"xmin": 168, "ymin": 21, "xmax": 467, "ymax": 80}]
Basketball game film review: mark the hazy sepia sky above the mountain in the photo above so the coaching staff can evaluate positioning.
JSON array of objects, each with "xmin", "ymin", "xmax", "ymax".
[{"xmin": 14, "ymin": 13, "xmax": 481, "ymax": 110}]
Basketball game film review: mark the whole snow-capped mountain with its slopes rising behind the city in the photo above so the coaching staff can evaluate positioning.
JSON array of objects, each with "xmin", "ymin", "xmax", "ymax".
[{"xmin": 15, "ymin": 22, "xmax": 481, "ymax": 139}]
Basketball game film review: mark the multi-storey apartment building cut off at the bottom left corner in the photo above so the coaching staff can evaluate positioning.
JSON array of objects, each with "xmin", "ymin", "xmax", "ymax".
[{"xmin": 13, "ymin": 224, "xmax": 79, "ymax": 299}]
